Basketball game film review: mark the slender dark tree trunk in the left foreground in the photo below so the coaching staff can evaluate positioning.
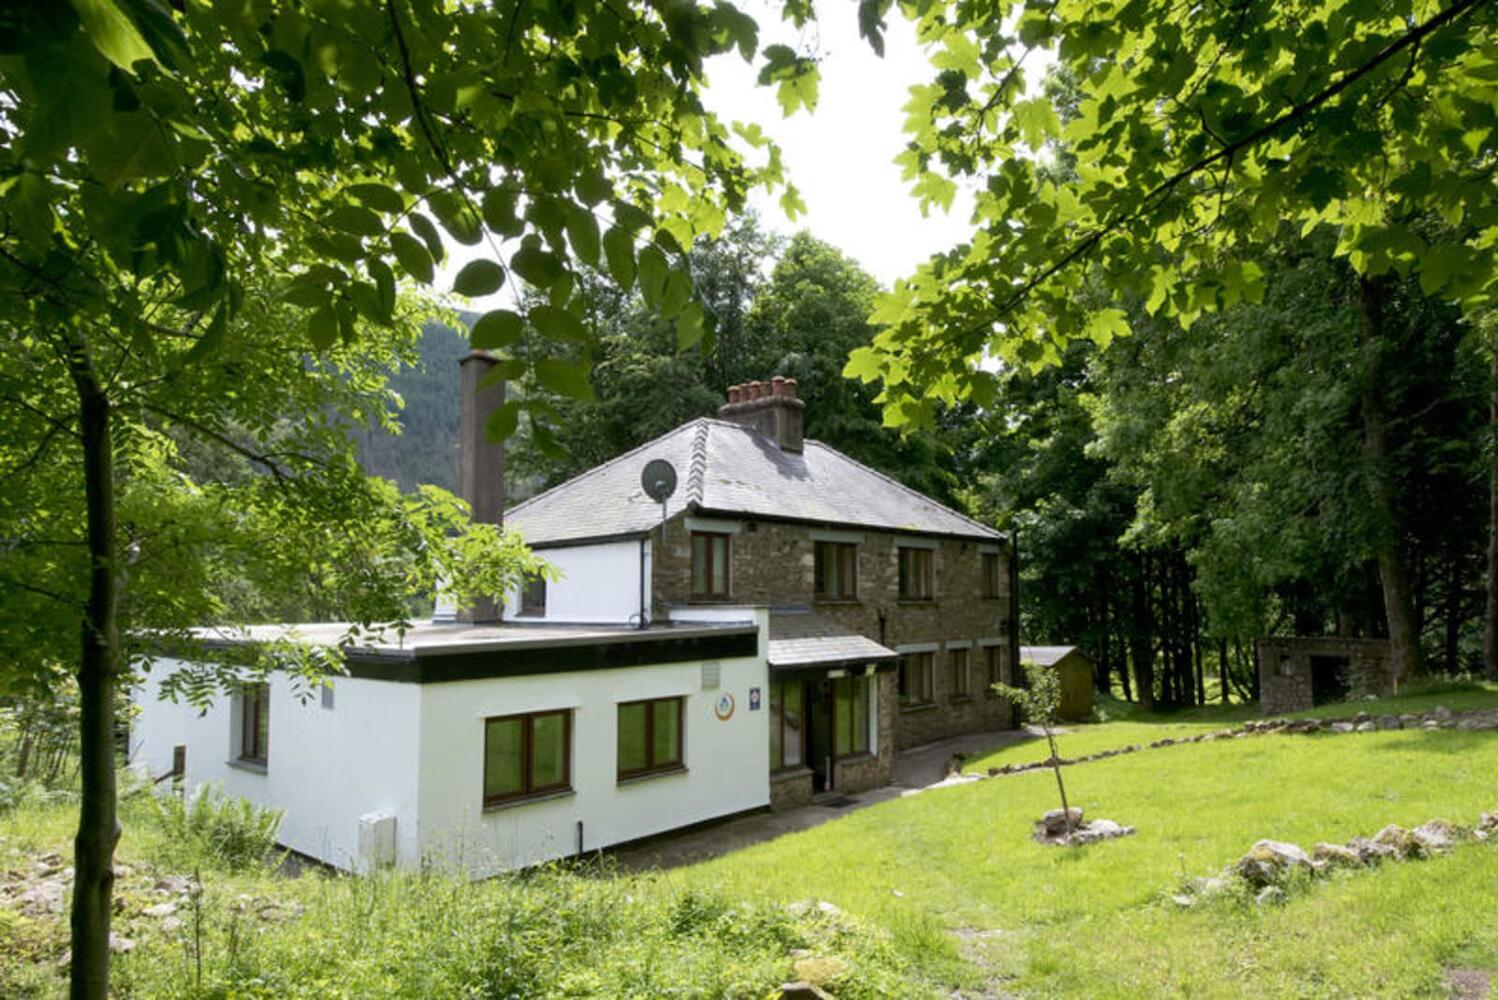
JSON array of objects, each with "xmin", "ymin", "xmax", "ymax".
[{"xmin": 69, "ymin": 341, "xmax": 120, "ymax": 1000}]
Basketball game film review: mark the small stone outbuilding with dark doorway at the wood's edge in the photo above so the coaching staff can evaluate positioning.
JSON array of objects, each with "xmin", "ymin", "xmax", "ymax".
[{"xmin": 1255, "ymin": 636, "xmax": 1398, "ymax": 716}]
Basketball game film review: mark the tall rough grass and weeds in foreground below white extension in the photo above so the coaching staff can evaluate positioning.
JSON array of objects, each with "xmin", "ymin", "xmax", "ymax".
[{"xmin": 0, "ymin": 796, "xmax": 936, "ymax": 1000}]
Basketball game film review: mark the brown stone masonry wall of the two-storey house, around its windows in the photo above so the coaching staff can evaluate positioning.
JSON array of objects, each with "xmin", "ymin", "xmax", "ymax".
[{"xmin": 652, "ymin": 515, "xmax": 1013, "ymax": 754}]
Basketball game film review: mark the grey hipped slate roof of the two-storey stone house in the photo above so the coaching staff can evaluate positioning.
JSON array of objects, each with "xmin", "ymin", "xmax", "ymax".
[{"xmin": 505, "ymin": 418, "xmax": 1004, "ymax": 545}]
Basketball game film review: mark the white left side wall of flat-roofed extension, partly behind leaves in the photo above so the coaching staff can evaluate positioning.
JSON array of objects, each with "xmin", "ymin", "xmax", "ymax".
[{"xmin": 130, "ymin": 660, "xmax": 421, "ymax": 868}]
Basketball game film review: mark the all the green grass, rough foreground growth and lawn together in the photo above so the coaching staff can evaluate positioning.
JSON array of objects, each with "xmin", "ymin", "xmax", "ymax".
[{"xmin": 0, "ymin": 684, "xmax": 1498, "ymax": 999}]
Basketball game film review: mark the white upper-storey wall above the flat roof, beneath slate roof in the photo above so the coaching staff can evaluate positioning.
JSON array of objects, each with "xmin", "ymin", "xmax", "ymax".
[{"xmin": 505, "ymin": 539, "xmax": 650, "ymax": 624}]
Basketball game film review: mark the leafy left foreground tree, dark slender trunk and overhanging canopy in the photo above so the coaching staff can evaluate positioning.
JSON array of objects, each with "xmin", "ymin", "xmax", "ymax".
[{"xmin": 0, "ymin": 0, "xmax": 815, "ymax": 997}]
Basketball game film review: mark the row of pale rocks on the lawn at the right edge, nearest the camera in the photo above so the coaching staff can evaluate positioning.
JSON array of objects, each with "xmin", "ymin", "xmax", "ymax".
[{"xmin": 1171, "ymin": 811, "xmax": 1498, "ymax": 906}]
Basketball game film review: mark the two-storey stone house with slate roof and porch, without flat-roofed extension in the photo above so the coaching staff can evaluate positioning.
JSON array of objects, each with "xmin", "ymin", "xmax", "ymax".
[{"xmin": 505, "ymin": 377, "xmax": 1017, "ymax": 807}]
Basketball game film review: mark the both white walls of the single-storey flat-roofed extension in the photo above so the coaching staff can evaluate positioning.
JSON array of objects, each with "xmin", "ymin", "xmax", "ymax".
[{"xmin": 132, "ymin": 601, "xmax": 770, "ymax": 876}]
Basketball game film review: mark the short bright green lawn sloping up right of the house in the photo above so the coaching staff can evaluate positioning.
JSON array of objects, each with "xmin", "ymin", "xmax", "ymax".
[{"xmin": 673, "ymin": 686, "xmax": 1498, "ymax": 997}]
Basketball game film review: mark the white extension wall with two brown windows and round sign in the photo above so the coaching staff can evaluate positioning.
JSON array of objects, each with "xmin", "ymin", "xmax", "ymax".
[{"xmin": 418, "ymin": 611, "xmax": 770, "ymax": 876}]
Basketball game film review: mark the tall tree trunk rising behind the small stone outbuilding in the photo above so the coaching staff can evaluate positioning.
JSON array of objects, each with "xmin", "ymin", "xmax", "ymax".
[{"xmin": 1357, "ymin": 277, "xmax": 1422, "ymax": 683}]
